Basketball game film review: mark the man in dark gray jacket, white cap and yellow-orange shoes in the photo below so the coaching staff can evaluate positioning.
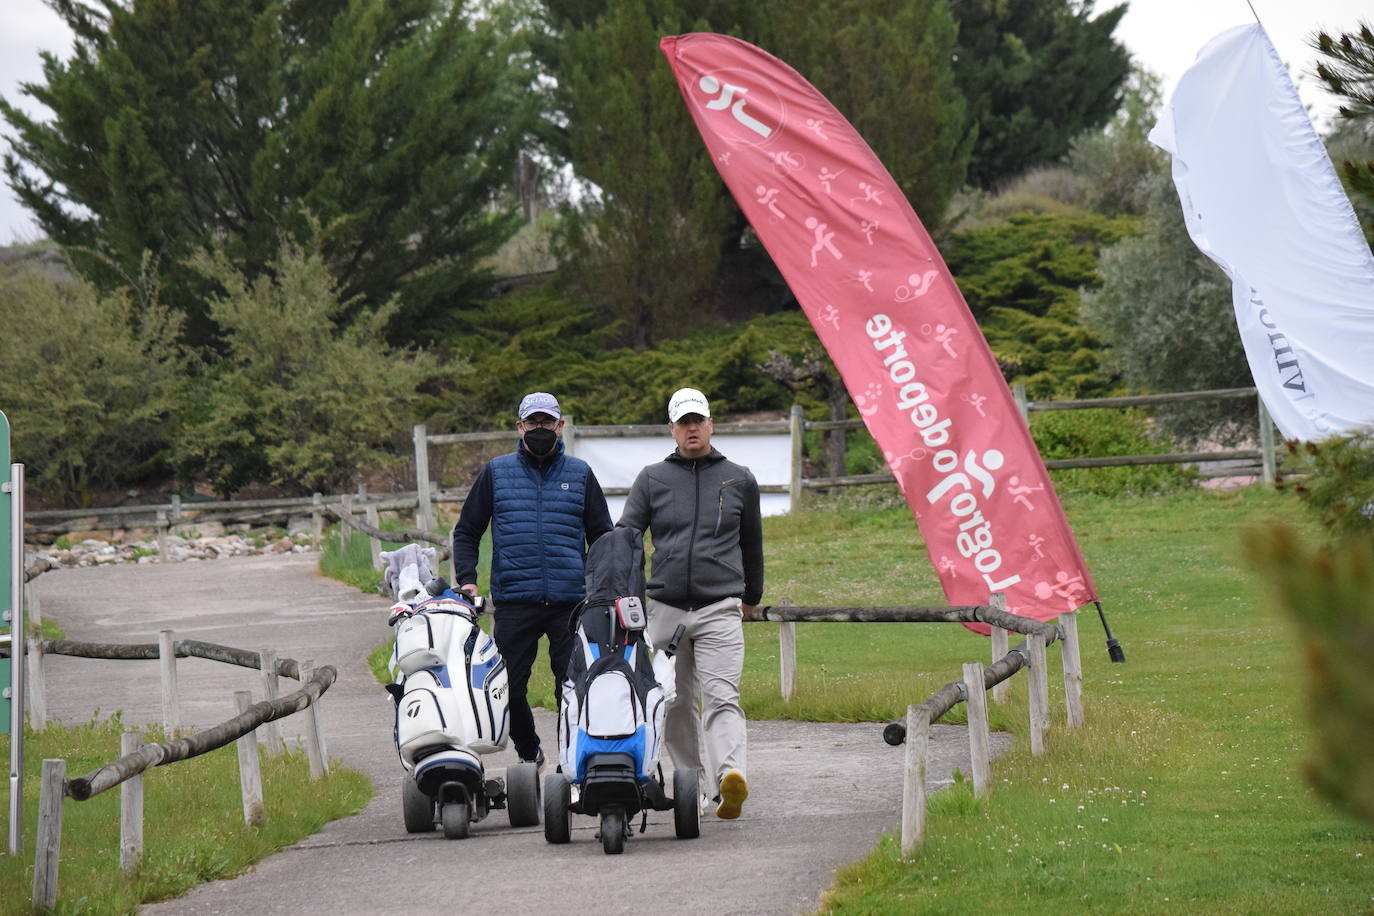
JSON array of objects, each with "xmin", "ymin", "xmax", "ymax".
[{"xmin": 617, "ymin": 389, "xmax": 764, "ymax": 818}]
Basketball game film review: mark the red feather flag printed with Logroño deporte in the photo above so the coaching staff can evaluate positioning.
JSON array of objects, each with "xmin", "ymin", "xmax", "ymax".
[{"xmin": 660, "ymin": 33, "xmax": 1096, "ymax": 632}]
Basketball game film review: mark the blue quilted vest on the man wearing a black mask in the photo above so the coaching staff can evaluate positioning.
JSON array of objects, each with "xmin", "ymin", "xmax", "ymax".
[{"xmin": 492, "ymin": 442, "xmax": 588, "ymax": 606}]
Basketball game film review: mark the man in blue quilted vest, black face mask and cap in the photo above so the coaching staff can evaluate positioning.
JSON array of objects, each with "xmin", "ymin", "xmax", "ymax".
[{"xmin": 453, "ymin": 391, "xmax": 611, "ymax": 765}]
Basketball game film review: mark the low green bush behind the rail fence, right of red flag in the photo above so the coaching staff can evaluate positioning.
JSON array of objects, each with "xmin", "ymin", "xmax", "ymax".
[{"xmin": 1031, "ymin": 408, "xmax": 1193, "ymax": 496}]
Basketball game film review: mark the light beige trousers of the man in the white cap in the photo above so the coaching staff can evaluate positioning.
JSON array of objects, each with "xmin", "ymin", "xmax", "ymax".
[{"xmin": 649, "ymin": 597, "xmax": 745, "ymax": 795}]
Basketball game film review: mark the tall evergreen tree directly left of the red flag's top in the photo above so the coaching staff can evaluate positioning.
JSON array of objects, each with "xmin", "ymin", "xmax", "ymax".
[{"xmin": 559, "ymin": 0, "xmax": 730, "ymax": 349}]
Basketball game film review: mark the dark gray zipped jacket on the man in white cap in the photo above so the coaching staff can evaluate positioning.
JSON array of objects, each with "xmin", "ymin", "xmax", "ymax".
[{"xmin": 617, "ymin": 449, "xmax": 764, "ymax": 611}]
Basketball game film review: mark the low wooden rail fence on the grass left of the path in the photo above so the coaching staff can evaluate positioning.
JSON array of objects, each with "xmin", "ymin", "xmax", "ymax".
[{"xmin": 29, "ymin": 630, "xmax": 338, "ymax": 909}]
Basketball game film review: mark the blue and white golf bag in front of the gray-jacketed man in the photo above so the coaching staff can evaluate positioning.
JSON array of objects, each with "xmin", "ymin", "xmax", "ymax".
[{"xmin": 558, "ymin": 527, "xmax": 673, "ymax": 784}]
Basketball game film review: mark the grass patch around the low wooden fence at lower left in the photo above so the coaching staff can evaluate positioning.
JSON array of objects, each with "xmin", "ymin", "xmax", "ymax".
[{"xmin": 0, "ymin": 714, "xmax": 372, "ymax": 915}]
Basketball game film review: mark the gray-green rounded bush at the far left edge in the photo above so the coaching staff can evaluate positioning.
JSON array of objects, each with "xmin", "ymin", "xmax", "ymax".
[{"xmin": 0, "ymin": 259, "xmax": 188, "ymax": 505}]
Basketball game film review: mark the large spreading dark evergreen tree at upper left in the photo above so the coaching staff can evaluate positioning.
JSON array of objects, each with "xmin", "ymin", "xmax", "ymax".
[{"xmin": 0, "ymin": 0, "xmax": 529, "ymax": 342}]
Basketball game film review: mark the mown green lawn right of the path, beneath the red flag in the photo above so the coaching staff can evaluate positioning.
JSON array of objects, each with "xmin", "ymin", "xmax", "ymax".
[{"xmin": 329, "ymin": 488, "xmax": 1374, "ymax": 913}]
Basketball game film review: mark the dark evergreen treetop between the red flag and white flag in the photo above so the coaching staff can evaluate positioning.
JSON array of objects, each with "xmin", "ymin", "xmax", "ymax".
[{"xmin": 951, "ymin": 0, "xmax": 1131, "ymax": 188}]
